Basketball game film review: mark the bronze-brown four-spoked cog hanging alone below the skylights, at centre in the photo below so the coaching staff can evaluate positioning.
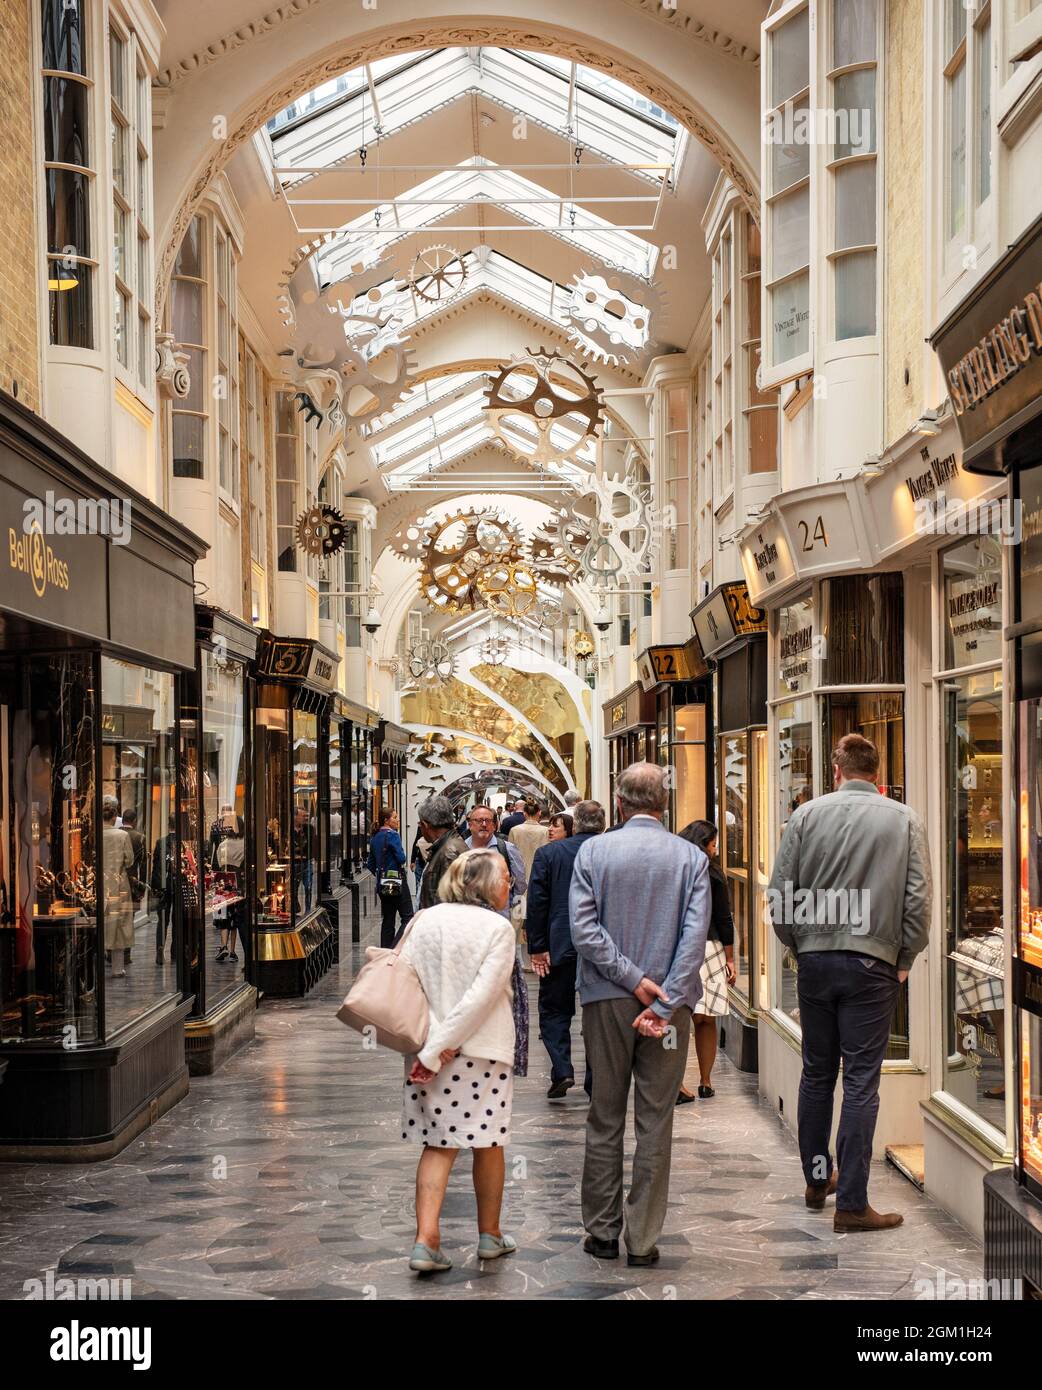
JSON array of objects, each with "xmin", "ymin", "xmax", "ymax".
[{"xmin": 485, "ymin": 348, "xmax": 603, "ymax": 464}]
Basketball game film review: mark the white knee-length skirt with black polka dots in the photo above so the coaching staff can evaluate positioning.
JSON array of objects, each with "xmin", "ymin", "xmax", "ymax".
[{"xmin": 402, "ymin": 1054, "xmax": 514, "ymax": 1148}]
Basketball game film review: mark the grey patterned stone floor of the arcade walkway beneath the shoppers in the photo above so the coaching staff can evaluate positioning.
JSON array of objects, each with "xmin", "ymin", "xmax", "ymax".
[{"xmin": 0, "ymin": 900, "xmax": 981, "ymax": 1300}]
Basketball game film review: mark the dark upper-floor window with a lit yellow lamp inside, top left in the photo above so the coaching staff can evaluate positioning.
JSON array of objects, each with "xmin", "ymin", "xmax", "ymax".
[{"xmin": 42, "ymin": 0, "xmax": 97, "ymax": 349}]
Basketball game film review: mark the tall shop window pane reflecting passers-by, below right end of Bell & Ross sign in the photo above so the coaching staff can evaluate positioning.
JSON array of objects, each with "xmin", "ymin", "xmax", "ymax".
[{"xmin": 101, "ymin": 656, "xmax": 178, "ymax": 1034}]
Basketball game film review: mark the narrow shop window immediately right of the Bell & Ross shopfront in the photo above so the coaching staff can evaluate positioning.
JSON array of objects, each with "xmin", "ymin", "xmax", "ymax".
[{"xmin": 201, "ymin": 649, "xmax": 250, "ymax": 1008}]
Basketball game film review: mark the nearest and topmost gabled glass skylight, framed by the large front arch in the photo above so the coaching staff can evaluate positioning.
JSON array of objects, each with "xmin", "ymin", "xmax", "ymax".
[{"xmin": 268, "ymin": 47, "xmax": 684, "ymax": 183}]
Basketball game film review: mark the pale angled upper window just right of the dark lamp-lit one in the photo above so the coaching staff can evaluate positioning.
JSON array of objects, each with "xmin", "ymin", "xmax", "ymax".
[{"xmin": 108, "ymin": 26, "xmax": 156, "ymax": 392}]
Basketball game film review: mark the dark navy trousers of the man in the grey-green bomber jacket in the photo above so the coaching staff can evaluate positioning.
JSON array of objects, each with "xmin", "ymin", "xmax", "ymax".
[{"xmin": 796, "ymin": 951, "xmax": 900, "ymax": 1211}]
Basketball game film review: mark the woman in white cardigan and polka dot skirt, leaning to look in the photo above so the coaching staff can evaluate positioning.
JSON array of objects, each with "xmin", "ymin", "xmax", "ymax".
[{"xmin": 402, "ymin": 849, "xmax": 517, "ymax": 1273}]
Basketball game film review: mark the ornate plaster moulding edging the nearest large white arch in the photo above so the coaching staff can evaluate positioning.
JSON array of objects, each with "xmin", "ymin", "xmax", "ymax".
[{"xmin": 156, "ymin": 21, "xmax": 760, "ymax": 316}]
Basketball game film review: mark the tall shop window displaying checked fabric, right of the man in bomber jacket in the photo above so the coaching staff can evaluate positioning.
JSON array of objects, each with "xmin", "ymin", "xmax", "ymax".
[{"xmin": 943, "ymin": 671, "xmax": 1006, "ymax": 1130}]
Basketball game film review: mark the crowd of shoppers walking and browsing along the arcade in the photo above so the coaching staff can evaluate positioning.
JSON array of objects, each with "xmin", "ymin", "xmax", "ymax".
[{"xmin": 358, "ymin": 735, "xmax": 929, "ymax": 1273}]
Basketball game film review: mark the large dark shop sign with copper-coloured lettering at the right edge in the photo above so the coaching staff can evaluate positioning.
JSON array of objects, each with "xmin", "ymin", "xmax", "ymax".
[{"xmin": 929, "ymin": 202, "xmax": 1042, "ymax": 473}]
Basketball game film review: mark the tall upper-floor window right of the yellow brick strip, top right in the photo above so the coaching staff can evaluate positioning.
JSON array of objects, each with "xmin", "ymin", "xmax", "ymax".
[{"xmin": 942, "ymin": 0, "xmax": 992, "ymax": 264}]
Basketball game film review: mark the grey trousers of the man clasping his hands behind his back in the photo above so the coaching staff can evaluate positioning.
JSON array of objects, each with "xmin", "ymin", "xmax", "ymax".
[{"xmin": 582, "ymin": 999, "xmax": 690, "ymax": 1255}]
